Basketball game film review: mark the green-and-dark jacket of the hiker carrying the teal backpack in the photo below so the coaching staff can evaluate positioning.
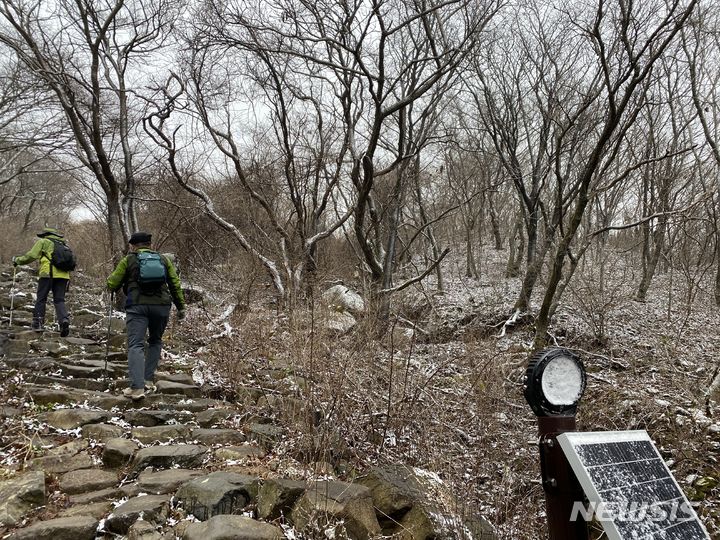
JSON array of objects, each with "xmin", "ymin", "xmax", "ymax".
[{"xmin": 107, "ymin": 248, "xmax": 185, "ymax": 311}]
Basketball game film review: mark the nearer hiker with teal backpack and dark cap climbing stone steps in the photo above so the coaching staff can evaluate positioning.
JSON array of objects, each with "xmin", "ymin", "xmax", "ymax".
[{"xmin": 107, "ymin": 232, "xmax": 185, "ymax": 400}]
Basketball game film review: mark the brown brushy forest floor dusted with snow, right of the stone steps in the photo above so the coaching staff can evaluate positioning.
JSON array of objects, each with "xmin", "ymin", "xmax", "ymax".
[{"xmin": 198, "ymin": 247, "xmax": 720, "ymax": 540}]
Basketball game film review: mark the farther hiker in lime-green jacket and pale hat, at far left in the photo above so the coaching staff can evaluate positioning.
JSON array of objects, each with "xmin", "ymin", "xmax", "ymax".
[{"xmin": 12, "ymin": 227, "xmax": 70, "ymax": 337}]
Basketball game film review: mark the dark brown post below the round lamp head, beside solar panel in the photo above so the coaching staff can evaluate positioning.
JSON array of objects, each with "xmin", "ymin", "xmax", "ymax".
[{"xmin": 538, "ymin": 416, "xmax": 589, "ymax": 540}]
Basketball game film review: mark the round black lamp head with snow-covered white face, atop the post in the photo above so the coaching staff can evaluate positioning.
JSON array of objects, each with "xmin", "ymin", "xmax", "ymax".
[{"xmin": 525, "ymin": 347, "xmax": 587, "ymax": 416}]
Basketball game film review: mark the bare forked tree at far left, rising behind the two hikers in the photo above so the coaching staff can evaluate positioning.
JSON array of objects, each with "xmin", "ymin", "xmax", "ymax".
[{"xmin": 0, "ymin": 0, "xmax": 179, "ymax": 253}]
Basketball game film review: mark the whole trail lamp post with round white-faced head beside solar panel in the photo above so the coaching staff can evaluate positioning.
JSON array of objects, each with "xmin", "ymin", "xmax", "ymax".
[{"xmin": 524, "ymin": 347, "xmax": 588, "ymax": 540}]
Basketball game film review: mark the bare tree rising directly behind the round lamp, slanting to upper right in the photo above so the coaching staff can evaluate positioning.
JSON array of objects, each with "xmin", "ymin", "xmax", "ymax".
[{"xmin": 534, "ymin": 0, "xmax": 695, "ymax": 347}]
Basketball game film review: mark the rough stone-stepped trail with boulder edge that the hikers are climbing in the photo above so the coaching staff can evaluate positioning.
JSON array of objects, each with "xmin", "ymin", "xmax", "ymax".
[{"xmin": 0, "ymin": 272, "xmax": 494, "ymax": 540}]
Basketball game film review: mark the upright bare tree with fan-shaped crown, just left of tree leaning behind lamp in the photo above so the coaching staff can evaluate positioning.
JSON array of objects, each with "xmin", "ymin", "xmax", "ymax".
[{"xmin": 466, "ymin": 5, "xmax": 599, "ymax": 319}]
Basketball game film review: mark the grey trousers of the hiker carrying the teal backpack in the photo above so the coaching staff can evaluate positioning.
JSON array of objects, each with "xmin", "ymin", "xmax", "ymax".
[{"xmin": 125, "ymin": 304, "xmax": 171, "ymax": 389}]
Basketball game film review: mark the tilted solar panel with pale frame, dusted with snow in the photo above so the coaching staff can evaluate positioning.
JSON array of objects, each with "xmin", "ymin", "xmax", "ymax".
[{"xmin": 557, "ymin": 431, "xmax": 710, "ymax": 540}]
